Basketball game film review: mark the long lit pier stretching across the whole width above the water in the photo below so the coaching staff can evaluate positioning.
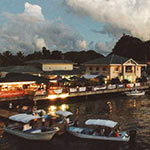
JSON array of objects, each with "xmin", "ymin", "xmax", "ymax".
[{"xmin": 0, "ymin": 83, "xmax": 150, "ymax": 103}]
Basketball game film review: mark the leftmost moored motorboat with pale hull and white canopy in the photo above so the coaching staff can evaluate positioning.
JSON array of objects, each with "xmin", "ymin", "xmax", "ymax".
[{"xmin": 3, "ymin": 113, "xmax": 59, "ymax": 141}]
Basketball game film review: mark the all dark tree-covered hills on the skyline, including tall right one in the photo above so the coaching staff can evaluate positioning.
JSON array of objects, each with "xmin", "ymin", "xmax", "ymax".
[{"xmin": 0, "ymin": 35, "xmax": 150, "ymax": 66}]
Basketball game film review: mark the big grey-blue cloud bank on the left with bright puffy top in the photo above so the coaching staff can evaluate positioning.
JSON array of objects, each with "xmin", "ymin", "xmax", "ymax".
[{"xmin": 0, "ymin": 3, "xmax": 86, "ymax": 54}]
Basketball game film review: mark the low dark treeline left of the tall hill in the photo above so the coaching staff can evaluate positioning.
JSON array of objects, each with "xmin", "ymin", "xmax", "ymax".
[{"xmin": 0, "ymin": 47, "xmax": 104, "ymax": 66}]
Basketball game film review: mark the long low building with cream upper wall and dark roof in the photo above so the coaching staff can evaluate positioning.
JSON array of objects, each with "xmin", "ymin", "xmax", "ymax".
[{"xmin": 25, "ymin": 59, "xmax": 81, "ymax": 79}]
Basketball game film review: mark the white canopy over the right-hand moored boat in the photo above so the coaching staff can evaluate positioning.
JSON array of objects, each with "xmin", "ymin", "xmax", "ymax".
[{"xmin": 85, "ymin": 119, "xmax": 117, "ymax": 128}]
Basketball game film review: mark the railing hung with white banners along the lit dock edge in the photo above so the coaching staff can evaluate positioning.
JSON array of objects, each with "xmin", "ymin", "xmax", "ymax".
[{"xmin": 34, "ymin": 82, "xmax": 150, "ymax": 100}]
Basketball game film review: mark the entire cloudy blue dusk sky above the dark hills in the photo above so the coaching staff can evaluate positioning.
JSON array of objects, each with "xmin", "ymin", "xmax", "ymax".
[{"xmin": 0, "ymin": 0, "xmax": 150, "ymax": 54}]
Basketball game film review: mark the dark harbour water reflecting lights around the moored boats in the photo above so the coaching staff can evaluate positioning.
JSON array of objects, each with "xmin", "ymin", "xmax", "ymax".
[{"xmin": 0, "ymin": 95, "xmax": 150, "ymax": 150}]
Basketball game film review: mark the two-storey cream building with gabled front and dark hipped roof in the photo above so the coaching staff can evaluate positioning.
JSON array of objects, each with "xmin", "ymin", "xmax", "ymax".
[{"xmin": 82, "ymin": 54, "xmax": 146, "ymax": 82}]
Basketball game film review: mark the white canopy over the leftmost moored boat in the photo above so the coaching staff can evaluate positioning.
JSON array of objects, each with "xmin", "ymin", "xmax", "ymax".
[{"xmin": 9, "ymin": 113, "xmax": 41, "ymax": 123}]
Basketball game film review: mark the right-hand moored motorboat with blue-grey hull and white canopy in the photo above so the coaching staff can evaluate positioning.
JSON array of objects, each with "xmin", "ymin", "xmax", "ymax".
[{"xmin": 67, "ymin": 119, "xmax": 136, "ymax": 142}]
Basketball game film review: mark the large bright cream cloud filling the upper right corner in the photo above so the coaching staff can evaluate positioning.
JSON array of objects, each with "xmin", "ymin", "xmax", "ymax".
[{"xmin": 65, "ymin": 0, "xmax": 150, "ymax": 40}]
